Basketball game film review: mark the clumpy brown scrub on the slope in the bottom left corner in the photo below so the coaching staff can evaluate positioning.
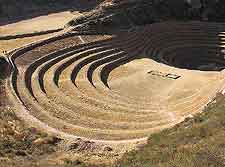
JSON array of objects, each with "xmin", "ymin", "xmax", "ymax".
[{"xmin": 0, "ymin": 108, "xmax": 60, "ymax": 164}]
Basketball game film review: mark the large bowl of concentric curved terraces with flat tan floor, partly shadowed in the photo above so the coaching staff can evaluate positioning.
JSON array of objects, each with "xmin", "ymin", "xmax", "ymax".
[{"xmin": 8, "ymin": 22, "xmax": 225, "ymax": 142}]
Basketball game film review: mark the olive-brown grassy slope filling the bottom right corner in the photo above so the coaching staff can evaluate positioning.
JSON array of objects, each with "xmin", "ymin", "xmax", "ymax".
[{"xmin": 118, "ymin": 93, "xmax": 225, "ymax": 167}]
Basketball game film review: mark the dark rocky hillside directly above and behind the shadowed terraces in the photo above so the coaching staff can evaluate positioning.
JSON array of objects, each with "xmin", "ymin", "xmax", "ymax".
[{"xmin": 67, "ymin": 0, "xmax": 225, "ymax": 33}]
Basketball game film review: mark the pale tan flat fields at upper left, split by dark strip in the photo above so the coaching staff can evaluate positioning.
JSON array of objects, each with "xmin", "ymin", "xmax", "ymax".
[{"xmin": 0, "ymin": 11, "xmax": 80, "ymax": 52}]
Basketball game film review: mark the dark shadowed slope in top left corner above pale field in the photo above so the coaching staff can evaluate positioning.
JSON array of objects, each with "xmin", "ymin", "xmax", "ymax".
[{"xmin": 0, "ymin": 0, "xmax": 103, "ymax": 25}]
